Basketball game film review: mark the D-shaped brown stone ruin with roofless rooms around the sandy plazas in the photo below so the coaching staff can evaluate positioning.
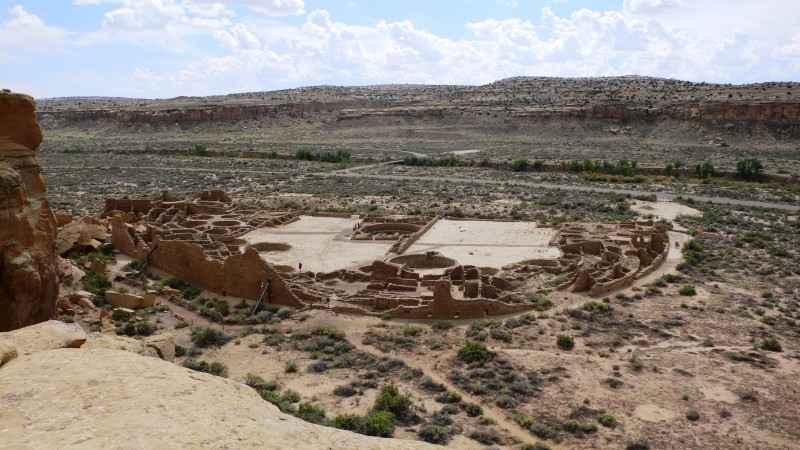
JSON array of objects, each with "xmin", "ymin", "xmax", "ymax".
[{"xmin": 104, "ymin": 191, "xmax": 670, "ymax": 319}]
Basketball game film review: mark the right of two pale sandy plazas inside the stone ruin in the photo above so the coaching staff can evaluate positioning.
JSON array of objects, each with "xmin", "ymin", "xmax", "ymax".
[{"xmin": 406, "ymin": 220, "xmax": 561, "ymax": 267}]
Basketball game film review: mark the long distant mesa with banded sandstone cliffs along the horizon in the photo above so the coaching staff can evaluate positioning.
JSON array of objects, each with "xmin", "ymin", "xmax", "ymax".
[{"xmin": 37, "ymin": 76, "xmax": 800, "ymax": 136}]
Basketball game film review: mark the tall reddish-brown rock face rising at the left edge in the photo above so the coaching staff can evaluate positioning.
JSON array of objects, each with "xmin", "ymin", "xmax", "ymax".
[{"xmin": 0, "ymin": 91, "xmax": 59, "ymax": 331}]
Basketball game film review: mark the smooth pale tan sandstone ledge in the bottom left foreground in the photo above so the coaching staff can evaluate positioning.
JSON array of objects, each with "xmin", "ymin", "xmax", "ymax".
[{"xmin": 0, "ymin": 321, "xmax": 433, "ymax": 449}]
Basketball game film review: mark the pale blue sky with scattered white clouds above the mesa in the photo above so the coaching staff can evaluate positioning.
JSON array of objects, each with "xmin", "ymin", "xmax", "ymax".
[{"xmin": 0, "ymin": 0, "xmax": 800, "ymax": 98}]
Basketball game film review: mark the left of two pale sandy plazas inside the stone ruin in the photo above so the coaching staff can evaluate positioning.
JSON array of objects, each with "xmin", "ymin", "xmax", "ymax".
[{"xmin": 242, "ymin": 216, "xmax": 394, "ymax": 272}]
